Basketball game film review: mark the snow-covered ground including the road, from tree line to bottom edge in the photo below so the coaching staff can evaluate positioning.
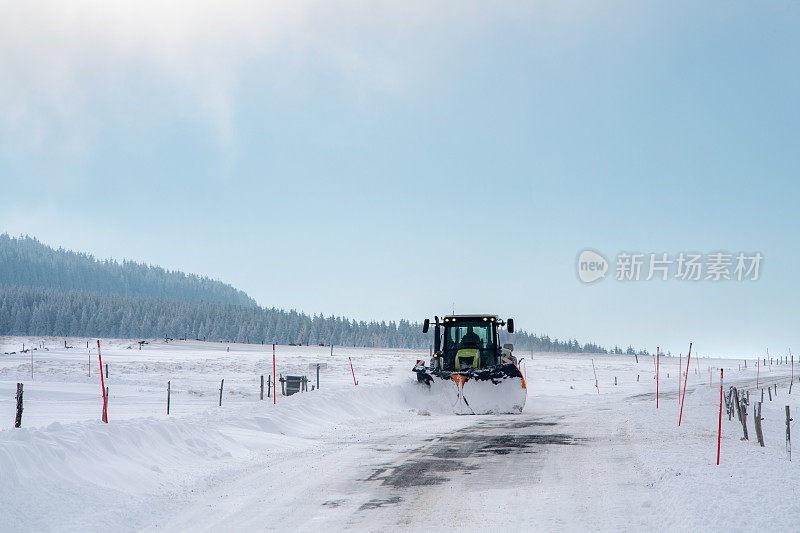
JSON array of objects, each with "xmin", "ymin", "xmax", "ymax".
[{"xmin": 0, "ymin": 337, "xmax": 800, "ymax": 531}]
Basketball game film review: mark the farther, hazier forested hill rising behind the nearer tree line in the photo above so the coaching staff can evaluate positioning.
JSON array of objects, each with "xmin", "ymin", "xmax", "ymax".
[{"xmin": 0, "ymin": 234, "xmax": 256, "ymax": 307}]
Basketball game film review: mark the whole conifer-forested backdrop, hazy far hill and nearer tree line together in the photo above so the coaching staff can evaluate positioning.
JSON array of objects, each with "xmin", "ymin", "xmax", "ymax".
[{"xmin": 0, "ymin": 234, "xmax": 633, "ymax": 353}]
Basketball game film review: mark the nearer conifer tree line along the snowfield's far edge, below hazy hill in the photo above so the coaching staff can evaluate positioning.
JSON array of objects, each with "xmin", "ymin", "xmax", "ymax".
[{"xmin": 0, "ymin": 287, "xmax": 620, "ymax": 353}]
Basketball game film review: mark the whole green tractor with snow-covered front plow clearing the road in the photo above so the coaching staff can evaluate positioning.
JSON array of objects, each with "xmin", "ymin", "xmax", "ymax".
[{"xmin": 413, "ymin": 315, "xmax": 527, "ymax": 414}]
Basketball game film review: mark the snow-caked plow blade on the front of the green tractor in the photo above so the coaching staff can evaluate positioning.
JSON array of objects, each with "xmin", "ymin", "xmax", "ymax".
[{"xmin": 414, "ymin": 363, "xmax": 527, "ymax": 415}]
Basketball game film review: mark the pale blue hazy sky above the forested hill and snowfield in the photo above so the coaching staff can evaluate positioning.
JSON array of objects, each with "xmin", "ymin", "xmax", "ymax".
[{"xmin": 0, "ymin": 0, "xmax": 800, "ymax": 357}]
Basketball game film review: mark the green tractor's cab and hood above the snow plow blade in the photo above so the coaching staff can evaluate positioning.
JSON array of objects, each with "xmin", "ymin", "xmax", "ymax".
[{"xmin": 423, "ymin": 315, "xmax": 514, "ymax": 372}]
